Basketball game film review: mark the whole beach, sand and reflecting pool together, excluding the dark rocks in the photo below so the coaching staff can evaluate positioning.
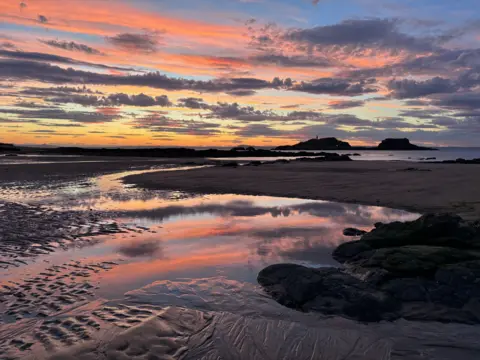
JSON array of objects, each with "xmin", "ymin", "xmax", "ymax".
[{"xmin": 0, "ymin": 157, "xmax": 480, "ymax": 360}]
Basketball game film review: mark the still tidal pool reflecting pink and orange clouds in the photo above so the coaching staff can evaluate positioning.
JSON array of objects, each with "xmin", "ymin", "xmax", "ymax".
[{"xmin": 0, "ymin": 165, "xmax": 419, "ymax": 299}]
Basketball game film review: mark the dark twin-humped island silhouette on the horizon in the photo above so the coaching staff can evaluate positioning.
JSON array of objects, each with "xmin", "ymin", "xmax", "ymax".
[{"xmin": 275, "ymin": 137, "xmax": 437, "ymax": 151}]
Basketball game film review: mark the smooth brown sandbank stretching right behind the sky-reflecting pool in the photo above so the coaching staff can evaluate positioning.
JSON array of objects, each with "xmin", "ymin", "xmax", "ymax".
[{"xmin": 124, "ymin": 161, "xmax": 480, "ymax": 219}]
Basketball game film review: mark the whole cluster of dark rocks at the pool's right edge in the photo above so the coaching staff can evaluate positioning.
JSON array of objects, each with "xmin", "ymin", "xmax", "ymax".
[{"xmin": 258, "ymin": 214, "xmax": 480, "ymax": 324}]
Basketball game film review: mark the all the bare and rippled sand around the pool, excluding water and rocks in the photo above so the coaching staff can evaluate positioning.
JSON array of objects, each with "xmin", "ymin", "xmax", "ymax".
[{"xmin": 0, "ymin": 159, "xmax": 480, "ymax": 360}]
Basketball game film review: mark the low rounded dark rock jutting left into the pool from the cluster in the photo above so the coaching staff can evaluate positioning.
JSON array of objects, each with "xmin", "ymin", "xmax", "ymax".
[{"xmin": 258, "ymin": 264, "xmax": 400, "ymax": 322}]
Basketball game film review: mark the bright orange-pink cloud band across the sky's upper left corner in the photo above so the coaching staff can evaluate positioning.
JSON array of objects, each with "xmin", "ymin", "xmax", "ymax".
[{"xmin": 0, "ymin": 0, "xmax": 245, "ymax": 45}]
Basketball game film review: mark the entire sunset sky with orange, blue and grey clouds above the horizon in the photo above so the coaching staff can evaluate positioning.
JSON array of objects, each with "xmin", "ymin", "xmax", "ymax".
[{"xmin": 0, "ymin": 0, "xmax": 480, "ymax": 147}]
